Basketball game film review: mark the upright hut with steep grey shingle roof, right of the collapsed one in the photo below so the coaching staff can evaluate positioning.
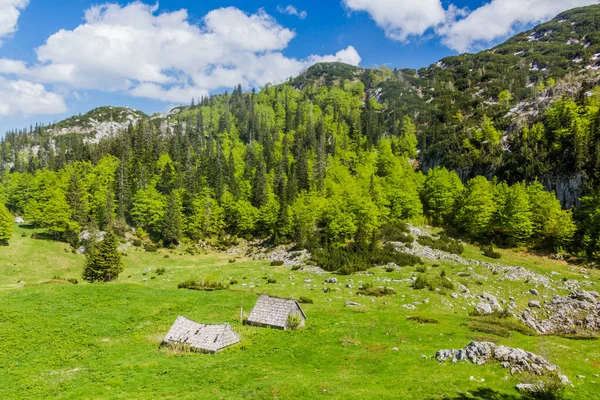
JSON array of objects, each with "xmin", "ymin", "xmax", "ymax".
[{"xmin": 247, "ymin": 295, "xmax": 306, "ymax": 330}]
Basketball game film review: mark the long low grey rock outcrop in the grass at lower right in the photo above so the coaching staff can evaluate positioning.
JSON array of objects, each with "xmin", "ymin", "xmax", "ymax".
[{"xmin": 435, "ymin": 342, "xmax": 566, "ymax": 378}]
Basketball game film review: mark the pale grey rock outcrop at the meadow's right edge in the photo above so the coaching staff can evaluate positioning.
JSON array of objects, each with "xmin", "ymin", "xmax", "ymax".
[{"xmin": 520, "ymin": 290, "xmax": 600, "ymax": 334}]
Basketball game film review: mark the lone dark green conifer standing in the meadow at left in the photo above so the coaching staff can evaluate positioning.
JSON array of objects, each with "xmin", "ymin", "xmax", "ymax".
[{"xmin": 83, "ymin": 231, "xmax": 124, "ymax": 283}]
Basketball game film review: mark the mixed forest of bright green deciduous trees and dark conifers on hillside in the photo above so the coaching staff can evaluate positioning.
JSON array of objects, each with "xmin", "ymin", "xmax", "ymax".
[{"xmin": 0, "ymin": 80, "xmax": 584, "ymax": 268}]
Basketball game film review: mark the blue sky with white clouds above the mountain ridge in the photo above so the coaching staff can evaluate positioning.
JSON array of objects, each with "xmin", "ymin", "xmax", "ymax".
[{"xmin": 0, "ymin": 0, "xmax": 598, "ymax": 135}]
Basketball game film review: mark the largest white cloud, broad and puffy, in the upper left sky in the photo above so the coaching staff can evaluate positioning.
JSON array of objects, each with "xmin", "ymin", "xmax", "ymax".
[{"xmin": 19, "ymin": 0, "xmax": 360, "ymax": 102}]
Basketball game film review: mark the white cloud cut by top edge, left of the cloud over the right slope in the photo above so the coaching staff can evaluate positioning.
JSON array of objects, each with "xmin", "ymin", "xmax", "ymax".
[{"xmin": 343, "ymin": 0, "xmax": 446, "ymax": 41}]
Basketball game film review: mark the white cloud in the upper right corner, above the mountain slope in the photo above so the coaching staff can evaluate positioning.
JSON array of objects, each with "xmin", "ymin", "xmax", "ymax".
[{"xmin": 438, "ymin": 0, "xmax": 598, "ymax": 52}]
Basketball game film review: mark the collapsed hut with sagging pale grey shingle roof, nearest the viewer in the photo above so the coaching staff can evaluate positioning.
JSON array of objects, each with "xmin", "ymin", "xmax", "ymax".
[{"xmin": 163, "ymin": 316, "xmax": 240, "ymax": 353}]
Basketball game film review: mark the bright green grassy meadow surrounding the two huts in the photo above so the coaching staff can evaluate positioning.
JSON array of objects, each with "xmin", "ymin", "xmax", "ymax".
[{"xmin": 0, "ymin": 228, "xmax": 600, "ymax": 400}]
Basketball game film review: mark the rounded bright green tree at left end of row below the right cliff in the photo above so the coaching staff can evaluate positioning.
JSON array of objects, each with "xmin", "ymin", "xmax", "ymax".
[{"xmin": 421, "ymin": 167, "xmax": 464, "ymax": 224}]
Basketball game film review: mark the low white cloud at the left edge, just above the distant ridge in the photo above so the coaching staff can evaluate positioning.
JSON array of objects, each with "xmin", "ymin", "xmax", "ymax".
[{"xmin": 0, "ymin": 77, "xmax": 67, "ymax": 117}]
